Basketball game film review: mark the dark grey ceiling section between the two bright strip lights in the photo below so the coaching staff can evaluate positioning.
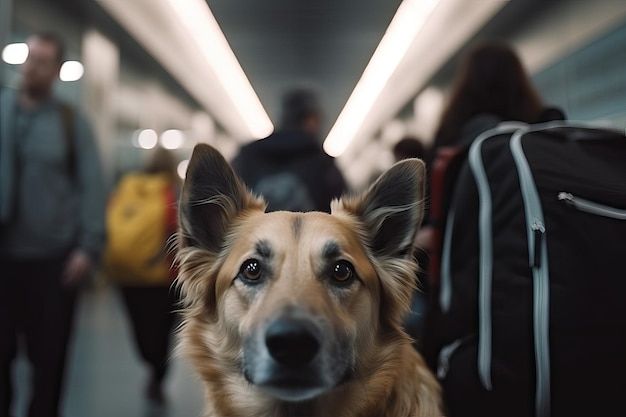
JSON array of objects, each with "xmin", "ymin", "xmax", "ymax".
[{"xmin": 208, "ymin": 0, "xmax": 401, "ymax": 136}]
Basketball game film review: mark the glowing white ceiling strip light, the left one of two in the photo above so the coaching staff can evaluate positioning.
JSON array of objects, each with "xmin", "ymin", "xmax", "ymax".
[{"xmin": 169, "ymin": 0, "xmax": 274, "ymax": 139}]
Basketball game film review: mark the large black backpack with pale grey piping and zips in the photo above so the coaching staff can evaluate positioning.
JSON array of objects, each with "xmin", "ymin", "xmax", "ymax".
[{"xmin": 423, "ymin": 122, "xmax": 626, "ymax": 417}]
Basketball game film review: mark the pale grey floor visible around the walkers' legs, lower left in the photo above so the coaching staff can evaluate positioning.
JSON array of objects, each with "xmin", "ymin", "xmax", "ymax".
[{"xmin": 14, "ymin": 288, "xmax": 202, "ymax": 417}]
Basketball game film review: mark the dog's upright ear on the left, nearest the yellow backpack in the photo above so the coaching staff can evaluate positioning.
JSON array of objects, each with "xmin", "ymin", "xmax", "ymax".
[{"xmin": 179, "ymin": 144, "xmax": 265, "ymax": 254}]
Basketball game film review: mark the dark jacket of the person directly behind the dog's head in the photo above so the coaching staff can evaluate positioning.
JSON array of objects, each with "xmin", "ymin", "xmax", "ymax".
[{"xmin": 232, "ymin": 130, "xmax": 346, "ymax": 212}]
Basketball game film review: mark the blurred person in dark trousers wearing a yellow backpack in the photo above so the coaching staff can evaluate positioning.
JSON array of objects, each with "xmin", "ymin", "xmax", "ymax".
[{"xmin": 104, "ymin": 147, "xmax": 182, "ymax": 405}]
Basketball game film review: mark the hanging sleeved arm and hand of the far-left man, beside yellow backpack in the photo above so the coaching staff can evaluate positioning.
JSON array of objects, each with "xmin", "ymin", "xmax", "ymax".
[{"xmin": 65, "ymin": 112, "xmax": 106, "ymax": 283}]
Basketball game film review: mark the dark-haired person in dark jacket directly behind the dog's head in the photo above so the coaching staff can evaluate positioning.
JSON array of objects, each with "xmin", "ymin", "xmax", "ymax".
[{"xmin": 232, "ymin": 89, "xmax": 346, "ymax": 212}]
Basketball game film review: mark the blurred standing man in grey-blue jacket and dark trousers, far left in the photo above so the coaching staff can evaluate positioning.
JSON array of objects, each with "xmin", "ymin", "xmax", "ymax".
[{"xmin": 0, "ymin": 34, "xmax": 105, "ymax": 417}]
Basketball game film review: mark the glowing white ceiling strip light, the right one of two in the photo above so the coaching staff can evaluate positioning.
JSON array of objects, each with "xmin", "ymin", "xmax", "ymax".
[{"xmin": 324, "ymin": 0, "xmax": 439, "ymax": 156}]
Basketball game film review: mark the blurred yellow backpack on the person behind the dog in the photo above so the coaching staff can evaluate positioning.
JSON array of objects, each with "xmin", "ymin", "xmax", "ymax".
[{"xmin": 104, "ymin": 173, "xmax": 176, "ymax": 286}]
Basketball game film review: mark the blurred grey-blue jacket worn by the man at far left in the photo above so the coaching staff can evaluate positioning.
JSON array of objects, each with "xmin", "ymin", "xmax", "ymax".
[{"xmin": 0, "ymin": 89, "xmax": 105, "ymax": 259}]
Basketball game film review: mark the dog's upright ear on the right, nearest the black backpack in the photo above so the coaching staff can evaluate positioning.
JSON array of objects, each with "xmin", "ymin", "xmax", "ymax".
[{"xmin": 338, "ymin": 159, "xmax": 426, "ymax": 258}]
